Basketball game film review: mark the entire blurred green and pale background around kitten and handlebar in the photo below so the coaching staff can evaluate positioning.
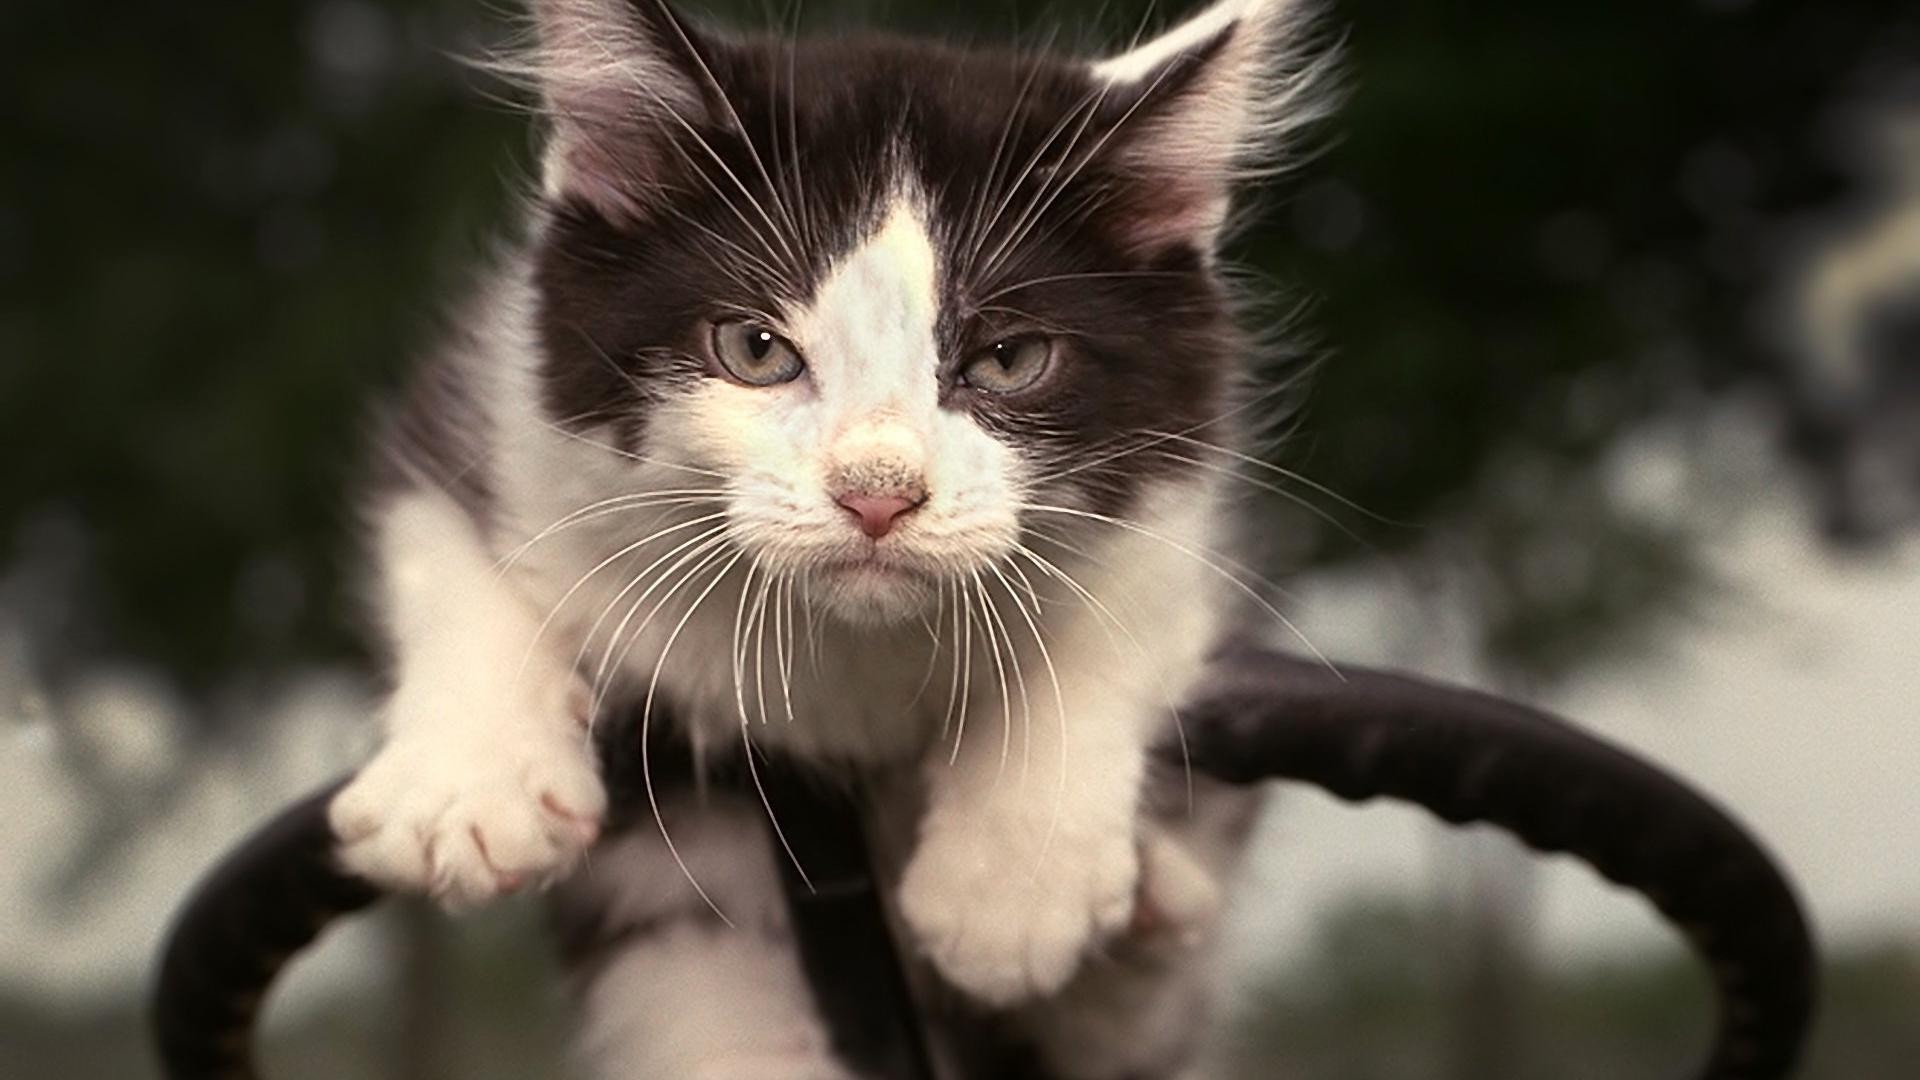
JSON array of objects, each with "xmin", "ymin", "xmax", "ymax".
[{"xmin": 0, "ymin": 0, "xmax": 1920, "ymax": 1080}]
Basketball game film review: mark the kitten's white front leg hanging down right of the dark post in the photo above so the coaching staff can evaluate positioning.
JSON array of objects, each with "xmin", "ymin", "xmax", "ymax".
[{"xmin": 900, "ymin": 625, "xmax": 1156, "ymax": 1005}]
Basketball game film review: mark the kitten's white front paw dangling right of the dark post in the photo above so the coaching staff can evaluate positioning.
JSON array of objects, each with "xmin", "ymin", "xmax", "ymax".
[{"xmin": 900, "ymin": 828, "xmax": 1140, "ymax": 1005}]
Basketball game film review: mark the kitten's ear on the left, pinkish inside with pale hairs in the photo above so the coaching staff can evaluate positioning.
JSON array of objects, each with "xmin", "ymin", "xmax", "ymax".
[{"xmin": 518, "ymin": 0, "xmax": 712, "ymax": 221}]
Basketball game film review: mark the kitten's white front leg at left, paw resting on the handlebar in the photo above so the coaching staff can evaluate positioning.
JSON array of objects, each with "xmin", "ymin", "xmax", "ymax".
[{"xmin": 330, "ymin": 488, "xmax": 607, "ymax": 903}]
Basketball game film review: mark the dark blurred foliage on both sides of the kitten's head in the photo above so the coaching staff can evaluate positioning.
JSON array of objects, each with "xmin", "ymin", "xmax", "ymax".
[{"xmin": 0, "ymin": 0, "xmax": 1920, "ymax": 682}]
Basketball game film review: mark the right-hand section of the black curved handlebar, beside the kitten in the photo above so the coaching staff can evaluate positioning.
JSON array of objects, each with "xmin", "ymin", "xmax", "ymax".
[{"xmin": 1181, "ymin": 648, "xmax": 1816, "ymax": 1080}]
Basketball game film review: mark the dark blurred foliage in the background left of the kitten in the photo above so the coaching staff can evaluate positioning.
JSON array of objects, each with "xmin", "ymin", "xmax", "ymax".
[{"xmin": 0, "ymin": 0, "xmax": 526, "ymax": 676}]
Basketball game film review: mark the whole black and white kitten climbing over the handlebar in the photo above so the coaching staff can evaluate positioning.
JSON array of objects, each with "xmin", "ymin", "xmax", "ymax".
[{"xmin": 332, "ymin": 0, "xmax": 1315, "ymax": 1080}]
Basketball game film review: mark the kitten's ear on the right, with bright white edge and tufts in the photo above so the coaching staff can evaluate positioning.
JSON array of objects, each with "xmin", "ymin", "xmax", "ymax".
[{"xmin": 1092, "ymin": 0, "xmax": 1329, "ymax": 250}]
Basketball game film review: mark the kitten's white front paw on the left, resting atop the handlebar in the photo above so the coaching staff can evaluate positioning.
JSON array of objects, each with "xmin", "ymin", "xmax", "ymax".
[{"xmin": 328, "ymin": 718, "xmax": 607, "ymax": 907}]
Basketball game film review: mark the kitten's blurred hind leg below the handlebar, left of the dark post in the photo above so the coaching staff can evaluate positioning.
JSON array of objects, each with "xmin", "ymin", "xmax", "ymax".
[{"xmin": 555, "ymin": 798, "xmax": 852, "ymax": 1080}]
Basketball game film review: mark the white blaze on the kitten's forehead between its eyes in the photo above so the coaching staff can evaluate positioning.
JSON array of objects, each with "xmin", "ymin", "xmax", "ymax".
[{"xmin": 795, "ymin": 188, "xmax": 939, "ymax": 415}]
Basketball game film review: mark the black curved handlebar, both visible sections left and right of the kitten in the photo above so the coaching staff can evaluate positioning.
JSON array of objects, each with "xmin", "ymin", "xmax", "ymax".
[{"xmin": 154, "ymin": 648, "xmax": 1814, "ymax": 1080}]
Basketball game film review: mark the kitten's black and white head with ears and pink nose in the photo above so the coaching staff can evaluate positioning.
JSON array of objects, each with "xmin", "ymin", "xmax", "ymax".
[{"xmin": 534, "ymin": 0, "xmax": 1311, "ymax": 621}]
